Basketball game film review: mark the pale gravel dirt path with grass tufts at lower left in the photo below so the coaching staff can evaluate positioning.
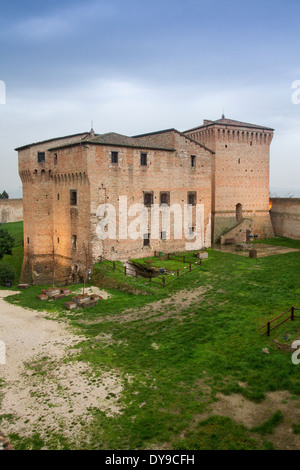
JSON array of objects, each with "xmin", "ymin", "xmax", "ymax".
[{"xmin": 0, "ymin": 290, "xmax": 123, "ymax": 448}]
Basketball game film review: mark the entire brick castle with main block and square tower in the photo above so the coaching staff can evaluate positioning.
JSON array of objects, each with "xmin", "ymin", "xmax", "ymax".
[{"xmin": 16, "ymin": 115, "xmax": 274, "ymax": 284}]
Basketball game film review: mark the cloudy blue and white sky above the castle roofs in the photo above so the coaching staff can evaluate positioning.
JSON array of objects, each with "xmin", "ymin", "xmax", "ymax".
[{"xmin": 0, "ymin": 0, "xmax": 300, "ymax": 197}]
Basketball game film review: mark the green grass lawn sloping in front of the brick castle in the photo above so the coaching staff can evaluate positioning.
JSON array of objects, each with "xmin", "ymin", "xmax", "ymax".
[{"xmin": 3, "ymin": 234, "xmax": 300, "ymax": 449}]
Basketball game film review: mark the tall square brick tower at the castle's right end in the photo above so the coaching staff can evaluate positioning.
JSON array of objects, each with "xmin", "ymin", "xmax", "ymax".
[{"xmin": 186, "ymin": 116, "xmax": 273, "ymax": 242}]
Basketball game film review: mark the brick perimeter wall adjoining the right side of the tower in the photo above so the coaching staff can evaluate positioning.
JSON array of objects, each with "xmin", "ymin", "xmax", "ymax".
[{"xmin": 270, "ymin": 197, "xmax": 300, "ymax": 240}]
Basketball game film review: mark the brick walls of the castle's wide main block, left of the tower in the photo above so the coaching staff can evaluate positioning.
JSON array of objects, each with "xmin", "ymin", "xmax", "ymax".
[{"xmin": 19, "ymin": 132, "xmax": 211, "ymax": 284}]
